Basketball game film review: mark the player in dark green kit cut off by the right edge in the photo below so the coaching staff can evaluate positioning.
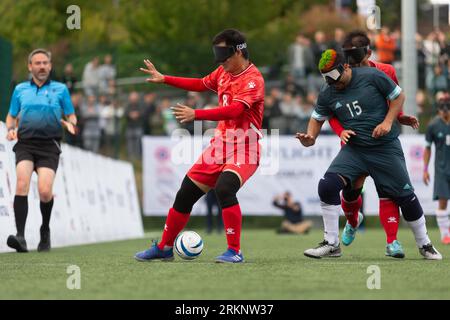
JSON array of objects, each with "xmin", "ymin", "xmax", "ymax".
[{"xmin": 423, "ymin": 94, "xmax": 450, "ymax": 244}]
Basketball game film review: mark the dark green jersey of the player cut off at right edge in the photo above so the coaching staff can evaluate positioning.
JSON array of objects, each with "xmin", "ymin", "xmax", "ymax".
[{"xmin": 425, "ymin": 116, "xmax": 450, "ymax": 177}]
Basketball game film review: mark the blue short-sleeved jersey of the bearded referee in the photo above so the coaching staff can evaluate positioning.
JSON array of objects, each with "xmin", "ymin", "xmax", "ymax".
[{"xmin": 9, "ymin": 79, "xmax": 75, "ymax": 140}]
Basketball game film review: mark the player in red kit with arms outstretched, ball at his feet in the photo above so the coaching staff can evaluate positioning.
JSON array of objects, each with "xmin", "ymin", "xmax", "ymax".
[{"xmin": 135, "ymin": 29, "xmax": 264, "ymax": 263}]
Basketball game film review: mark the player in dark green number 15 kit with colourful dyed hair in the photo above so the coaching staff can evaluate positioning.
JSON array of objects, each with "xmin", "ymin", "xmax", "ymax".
[{"xmin": 297, "ymin": 50, "xmax": 442, "ymax": 260}]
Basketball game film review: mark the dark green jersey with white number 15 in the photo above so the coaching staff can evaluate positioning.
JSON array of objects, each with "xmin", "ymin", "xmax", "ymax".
[{"xmin": 312, "ymin": 67, "xmax": 402, "ymax": 147}]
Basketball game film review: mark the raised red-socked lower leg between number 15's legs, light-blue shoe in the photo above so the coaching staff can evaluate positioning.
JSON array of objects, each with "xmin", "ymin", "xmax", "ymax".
[{"xmin": 341, "ymin": 188, "xmax": 364, "ymax": 246}]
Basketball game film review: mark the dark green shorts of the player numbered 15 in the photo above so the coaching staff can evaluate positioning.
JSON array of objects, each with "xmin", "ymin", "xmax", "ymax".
[{"xmin": 327, "ymin": 139, "xmax": 414, "ymax": 198}]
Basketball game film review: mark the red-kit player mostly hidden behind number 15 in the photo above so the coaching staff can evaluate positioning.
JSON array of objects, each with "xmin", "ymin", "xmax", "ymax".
[{"xmin": 330, "ymin": 31, "xmax": 419, "ymax": 258}]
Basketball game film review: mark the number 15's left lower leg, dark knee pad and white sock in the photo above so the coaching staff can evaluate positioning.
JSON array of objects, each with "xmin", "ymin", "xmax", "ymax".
[{"xmin": 304, "ymin": 172, "xmax": 344, "ymax": 259}]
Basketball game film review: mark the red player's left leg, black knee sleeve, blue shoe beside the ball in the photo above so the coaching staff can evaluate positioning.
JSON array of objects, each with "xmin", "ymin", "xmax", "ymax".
[{"xmin": 134, "ymin": 176, "xmax": 205, "ymax": 261}]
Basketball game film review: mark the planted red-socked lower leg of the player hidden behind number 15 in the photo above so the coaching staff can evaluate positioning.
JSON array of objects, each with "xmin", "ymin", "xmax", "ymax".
[{"xmin": 380, "ymin": 198, "xmax": 405, "ymax": 258}]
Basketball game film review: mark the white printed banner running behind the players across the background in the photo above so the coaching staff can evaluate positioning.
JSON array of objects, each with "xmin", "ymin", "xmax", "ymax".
[{"xmin": 143, "ymin": 135, "xmax": 437, "ymax": 216}]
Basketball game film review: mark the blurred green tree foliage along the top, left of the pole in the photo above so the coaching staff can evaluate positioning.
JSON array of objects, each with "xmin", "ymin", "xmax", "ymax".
[{"xmin": 0, "ymin": 0, "xmax": 328, "ymax": 78}]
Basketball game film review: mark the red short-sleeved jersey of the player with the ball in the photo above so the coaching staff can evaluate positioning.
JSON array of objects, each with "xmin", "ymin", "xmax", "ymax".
[{"xmin": 202, "ymin": 63, "xmax": 264, "ymax": 142}]
